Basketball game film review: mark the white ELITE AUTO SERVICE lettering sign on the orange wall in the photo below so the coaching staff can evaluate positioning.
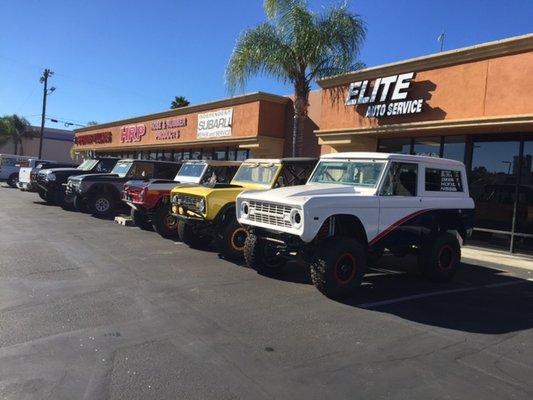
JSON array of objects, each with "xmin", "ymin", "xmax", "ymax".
[{"xmin": 345, "ymin": 72, "xmax": 424, "ymax": 118}]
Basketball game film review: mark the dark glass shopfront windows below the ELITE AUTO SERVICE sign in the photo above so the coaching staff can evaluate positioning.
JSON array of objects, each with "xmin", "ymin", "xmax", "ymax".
[{"xmin": 378, "ymin": 134, "xmax": 533, "ymax": 254}]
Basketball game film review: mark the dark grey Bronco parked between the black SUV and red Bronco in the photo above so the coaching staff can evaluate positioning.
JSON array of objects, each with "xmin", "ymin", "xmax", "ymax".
[{"xmin": 66, "ymin": 159, "xmax": 181, "ymax": 218}]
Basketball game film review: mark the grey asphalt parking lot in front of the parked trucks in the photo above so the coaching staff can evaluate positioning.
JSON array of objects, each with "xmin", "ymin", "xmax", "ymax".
[{"xmin": 0, "ymin": 187, "xmax": 533, "ymax": 400}]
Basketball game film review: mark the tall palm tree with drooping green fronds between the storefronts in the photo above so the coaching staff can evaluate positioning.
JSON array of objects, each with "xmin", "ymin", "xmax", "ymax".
[{"xmin": 226, "ymin": 0, "xmax": 366, "ymax": 156}]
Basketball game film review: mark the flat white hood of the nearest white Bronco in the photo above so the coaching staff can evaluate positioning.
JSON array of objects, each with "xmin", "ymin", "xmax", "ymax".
[{"xmin": 240, "ymin": 183, "xmax": 376, "ymax": 203}]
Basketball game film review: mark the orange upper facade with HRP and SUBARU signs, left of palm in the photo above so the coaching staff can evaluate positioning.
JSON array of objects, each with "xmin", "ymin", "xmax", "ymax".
[{"xmin": 75, "ymin": 93, "xmax": 290, "ymax": 161}]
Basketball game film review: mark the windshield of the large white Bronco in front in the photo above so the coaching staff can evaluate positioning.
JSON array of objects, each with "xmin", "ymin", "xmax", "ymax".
[{"xmin": 309, "ymin": 160, "xmax": 385, "ymax": 188}]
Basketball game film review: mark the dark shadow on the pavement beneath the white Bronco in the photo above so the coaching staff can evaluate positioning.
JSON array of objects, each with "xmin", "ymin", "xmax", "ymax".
[{"xmin": 270, "ymin": 257, "xmax": 533, "ymax": 334}]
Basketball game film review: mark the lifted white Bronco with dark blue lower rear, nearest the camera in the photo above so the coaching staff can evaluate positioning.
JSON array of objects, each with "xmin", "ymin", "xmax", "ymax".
[{"xmin": 237, "ymin": 153, "xmax": 474, "ymax": 298}]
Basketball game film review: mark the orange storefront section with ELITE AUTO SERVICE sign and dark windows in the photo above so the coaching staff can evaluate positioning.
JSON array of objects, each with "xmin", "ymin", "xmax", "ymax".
[{"xmin": 315, "ymin": 35, "xmax": 533, "ymax": 252}]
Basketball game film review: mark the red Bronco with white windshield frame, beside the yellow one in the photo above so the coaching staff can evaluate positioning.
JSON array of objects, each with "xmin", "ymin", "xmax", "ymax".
[{"xmin": 123, "ymin": 160, "xmax": 241, "ymax": 238}]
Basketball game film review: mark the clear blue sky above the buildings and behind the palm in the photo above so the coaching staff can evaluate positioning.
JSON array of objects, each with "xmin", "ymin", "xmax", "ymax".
[{"xmin": 0, "ymin": 0, "xmax": 533, "ymax": 128}]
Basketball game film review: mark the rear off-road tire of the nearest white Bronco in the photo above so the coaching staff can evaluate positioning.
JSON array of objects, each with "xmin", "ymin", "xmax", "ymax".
[{"xmin": 418, "ymin": 232, "xmax": 461, "ymax": 282}]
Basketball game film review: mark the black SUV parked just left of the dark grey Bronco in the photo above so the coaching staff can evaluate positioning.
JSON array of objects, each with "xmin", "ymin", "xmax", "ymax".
[{"xmin": 32, "ymin": 157, "xmax": 119, "ymax": 208}]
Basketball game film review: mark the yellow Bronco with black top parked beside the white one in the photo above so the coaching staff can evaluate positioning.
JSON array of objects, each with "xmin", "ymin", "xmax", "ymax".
[{"xmin": 170, "ymin": 158, "xmax": 317, "ymax": 259}]
